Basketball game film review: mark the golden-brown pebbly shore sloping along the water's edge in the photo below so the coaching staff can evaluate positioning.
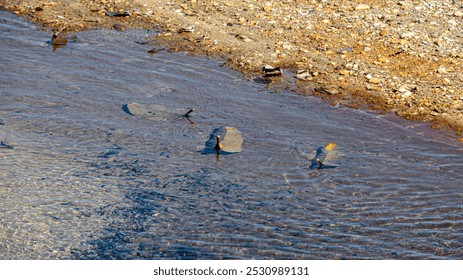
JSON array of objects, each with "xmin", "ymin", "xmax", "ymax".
[{"xmin": 0, "ymin": 0, "xmax": 463, "ymax": 137}]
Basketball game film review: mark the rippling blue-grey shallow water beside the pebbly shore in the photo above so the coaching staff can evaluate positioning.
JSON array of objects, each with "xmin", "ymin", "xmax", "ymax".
[{"xmin": 0, "ymin": 12, "xmax": 463, "ymax": 259}]
